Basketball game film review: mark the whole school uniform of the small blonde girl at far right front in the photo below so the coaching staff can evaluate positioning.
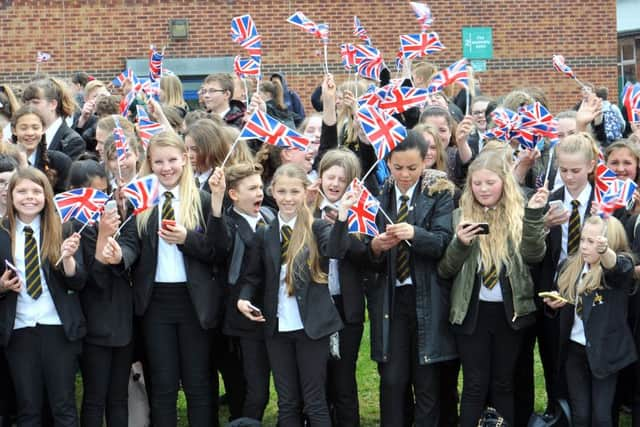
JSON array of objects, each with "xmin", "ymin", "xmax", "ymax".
[{"xmin": 558, "ymin": 255, "xmax": 637, "ymax": 427}]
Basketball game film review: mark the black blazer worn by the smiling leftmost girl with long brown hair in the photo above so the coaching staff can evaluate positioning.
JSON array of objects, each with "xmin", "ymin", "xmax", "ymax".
[{"xmin": 0, "ymin": 219, "xmax": 87, "ymax": 347}]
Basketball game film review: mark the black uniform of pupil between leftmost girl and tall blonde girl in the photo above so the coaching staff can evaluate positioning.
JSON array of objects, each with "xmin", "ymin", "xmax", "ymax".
[{"xmin": 74, "ymin": 223, "xmax": 134, "ymax": 427}]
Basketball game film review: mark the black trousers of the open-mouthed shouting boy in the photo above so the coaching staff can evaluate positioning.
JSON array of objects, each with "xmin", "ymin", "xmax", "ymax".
[{"xmin": 240, "ymin": 338, "xmax": 271, "ymax": 420}]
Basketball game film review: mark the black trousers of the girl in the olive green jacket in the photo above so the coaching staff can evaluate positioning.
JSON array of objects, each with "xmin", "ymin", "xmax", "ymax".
[{"xmin": 456, "ymin": 301, "xmax": 523, "ymax": 427}]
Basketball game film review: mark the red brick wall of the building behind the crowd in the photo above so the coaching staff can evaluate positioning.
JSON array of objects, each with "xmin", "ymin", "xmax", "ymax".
[{"xmin": 0, "ymin": 0, "xmax": 617, "ymax": 111}]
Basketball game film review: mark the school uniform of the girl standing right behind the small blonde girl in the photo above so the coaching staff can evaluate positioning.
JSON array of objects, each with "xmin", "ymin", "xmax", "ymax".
[{"xmin": 515, "ymin": 184, "xmax": 593, "ymax": 425}]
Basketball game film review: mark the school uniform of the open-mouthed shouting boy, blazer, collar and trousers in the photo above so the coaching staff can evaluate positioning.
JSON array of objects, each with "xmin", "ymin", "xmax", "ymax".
[{"xmin": 207, "ymin": 206, "xmax": 274, "ymax": 420}]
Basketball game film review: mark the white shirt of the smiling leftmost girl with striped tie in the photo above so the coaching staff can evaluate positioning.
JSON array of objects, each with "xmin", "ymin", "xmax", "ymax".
[{"xmin": 13, "ymin": 216, "xmax": 62, "ymax": 329}]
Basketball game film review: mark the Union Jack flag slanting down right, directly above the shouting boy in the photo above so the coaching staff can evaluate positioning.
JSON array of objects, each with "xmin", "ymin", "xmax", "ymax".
[{"xmin": 239, "ymin": 110, "xmax": 310, "ymax": 151}]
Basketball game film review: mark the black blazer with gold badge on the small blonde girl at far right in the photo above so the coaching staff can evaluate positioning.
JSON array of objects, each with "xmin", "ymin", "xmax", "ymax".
[{"xmin": 559, "ymin": 255, "xmax": 637, "ymax": 378}]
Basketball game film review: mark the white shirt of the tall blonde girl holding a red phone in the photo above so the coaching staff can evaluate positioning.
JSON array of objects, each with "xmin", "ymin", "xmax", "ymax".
[{"xmin": 155, "ymin": 184, "xmax": 187, "ymax": 283}]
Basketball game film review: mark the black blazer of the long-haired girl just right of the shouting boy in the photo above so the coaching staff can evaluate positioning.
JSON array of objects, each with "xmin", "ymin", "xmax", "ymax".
[{"xmin": 238, "ymin": 220, "xmax": 348, "ymax": 340}]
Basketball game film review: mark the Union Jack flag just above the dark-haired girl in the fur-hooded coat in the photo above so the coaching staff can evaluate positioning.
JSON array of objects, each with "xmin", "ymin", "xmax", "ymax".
[{"xmin": 357, "ymin": 105, "xmax": 407, "ymax": 160}]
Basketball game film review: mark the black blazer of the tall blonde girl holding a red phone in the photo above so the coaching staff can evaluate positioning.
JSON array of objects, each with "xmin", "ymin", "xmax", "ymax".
[{"xmin": 116, "ymin": 191, "xmax": 221, "ymax": 329}]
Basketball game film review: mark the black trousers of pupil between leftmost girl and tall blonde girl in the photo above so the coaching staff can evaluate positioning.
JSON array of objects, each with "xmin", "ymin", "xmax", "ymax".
[{"xmin": 80, "ymin": 341, "xmax": 133, "ymax": 427}]
